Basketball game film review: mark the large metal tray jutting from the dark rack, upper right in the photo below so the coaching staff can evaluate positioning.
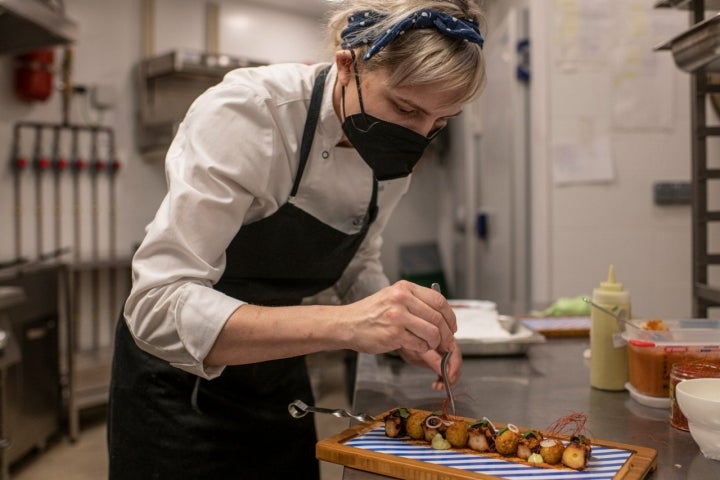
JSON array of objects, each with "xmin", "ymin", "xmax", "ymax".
[{"xmin": 655, "ymin": 13, "xmax": 720, "ymax": 73}]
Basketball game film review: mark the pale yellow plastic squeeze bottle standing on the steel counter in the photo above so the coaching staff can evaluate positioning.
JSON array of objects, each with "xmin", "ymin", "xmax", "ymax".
[{"xmin": 590, "ymin": 265, "xmax": 630, "ymax": 390}]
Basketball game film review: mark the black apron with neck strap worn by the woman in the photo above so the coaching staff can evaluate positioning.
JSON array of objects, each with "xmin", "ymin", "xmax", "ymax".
[{"xmin": 108, "ymin": 69, "xmax": 377, "ymax": 480}]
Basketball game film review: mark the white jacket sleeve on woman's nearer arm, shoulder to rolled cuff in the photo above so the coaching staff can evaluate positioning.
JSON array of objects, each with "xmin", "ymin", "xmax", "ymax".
[{"xmin": 124, "ymin": 79, "xmax": 282, "ymax": 378}]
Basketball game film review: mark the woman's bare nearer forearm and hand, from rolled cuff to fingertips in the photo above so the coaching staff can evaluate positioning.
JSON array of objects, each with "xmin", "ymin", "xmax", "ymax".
[{"xmin": 204, "ymin": 281, "xmax": 457, "ymax": 371}]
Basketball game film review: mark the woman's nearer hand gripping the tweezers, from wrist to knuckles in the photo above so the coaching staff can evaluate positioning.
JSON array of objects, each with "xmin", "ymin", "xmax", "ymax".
[{"xmin": 338, "ymin": 280, "xmax": 457, "ymax": 354}]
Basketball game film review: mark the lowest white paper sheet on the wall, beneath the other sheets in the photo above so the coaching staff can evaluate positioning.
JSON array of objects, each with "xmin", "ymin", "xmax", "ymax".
[{"xmin": 552, "ymin": 118, "xmax": 615, "ymax": 185}]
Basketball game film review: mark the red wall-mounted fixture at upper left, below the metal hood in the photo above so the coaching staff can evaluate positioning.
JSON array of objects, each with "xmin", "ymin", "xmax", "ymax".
[{"xmin": 15, "ymin": 49, "xmax": 55, "ymax": 102}]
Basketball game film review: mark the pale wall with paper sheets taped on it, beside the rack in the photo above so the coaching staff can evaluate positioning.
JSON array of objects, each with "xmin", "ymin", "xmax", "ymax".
[{"xmin": 530, "ymin": 0, "xmax": 704, "ymax": 317}]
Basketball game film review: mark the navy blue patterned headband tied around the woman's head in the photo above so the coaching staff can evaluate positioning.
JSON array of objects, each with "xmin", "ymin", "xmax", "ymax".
[{"xmin": 340, "ymin": 8, "xmax": 485, "ymax": 60}]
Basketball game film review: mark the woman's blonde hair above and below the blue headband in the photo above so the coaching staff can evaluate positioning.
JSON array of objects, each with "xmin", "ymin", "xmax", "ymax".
[{"xmin": 328, "ymin": 0, "xmax": 485, "ymax": 102}]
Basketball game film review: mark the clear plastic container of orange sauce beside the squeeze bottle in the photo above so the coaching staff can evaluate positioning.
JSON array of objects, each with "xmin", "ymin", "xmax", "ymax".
[{"xmin": 623, "ymin": 319, "xmax": 720, "ymax": 397}]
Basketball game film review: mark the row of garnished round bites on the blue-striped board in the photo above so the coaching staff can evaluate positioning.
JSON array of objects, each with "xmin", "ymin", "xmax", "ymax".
[{"xmin": 384, "ymin": 407, "xmax": 592, "ymax": 470}]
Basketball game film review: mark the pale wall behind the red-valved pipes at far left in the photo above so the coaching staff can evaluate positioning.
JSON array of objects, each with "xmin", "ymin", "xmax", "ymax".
[{"xmin": 0, "ymin": 0, "xmax": 158, "ymax": 260}]
